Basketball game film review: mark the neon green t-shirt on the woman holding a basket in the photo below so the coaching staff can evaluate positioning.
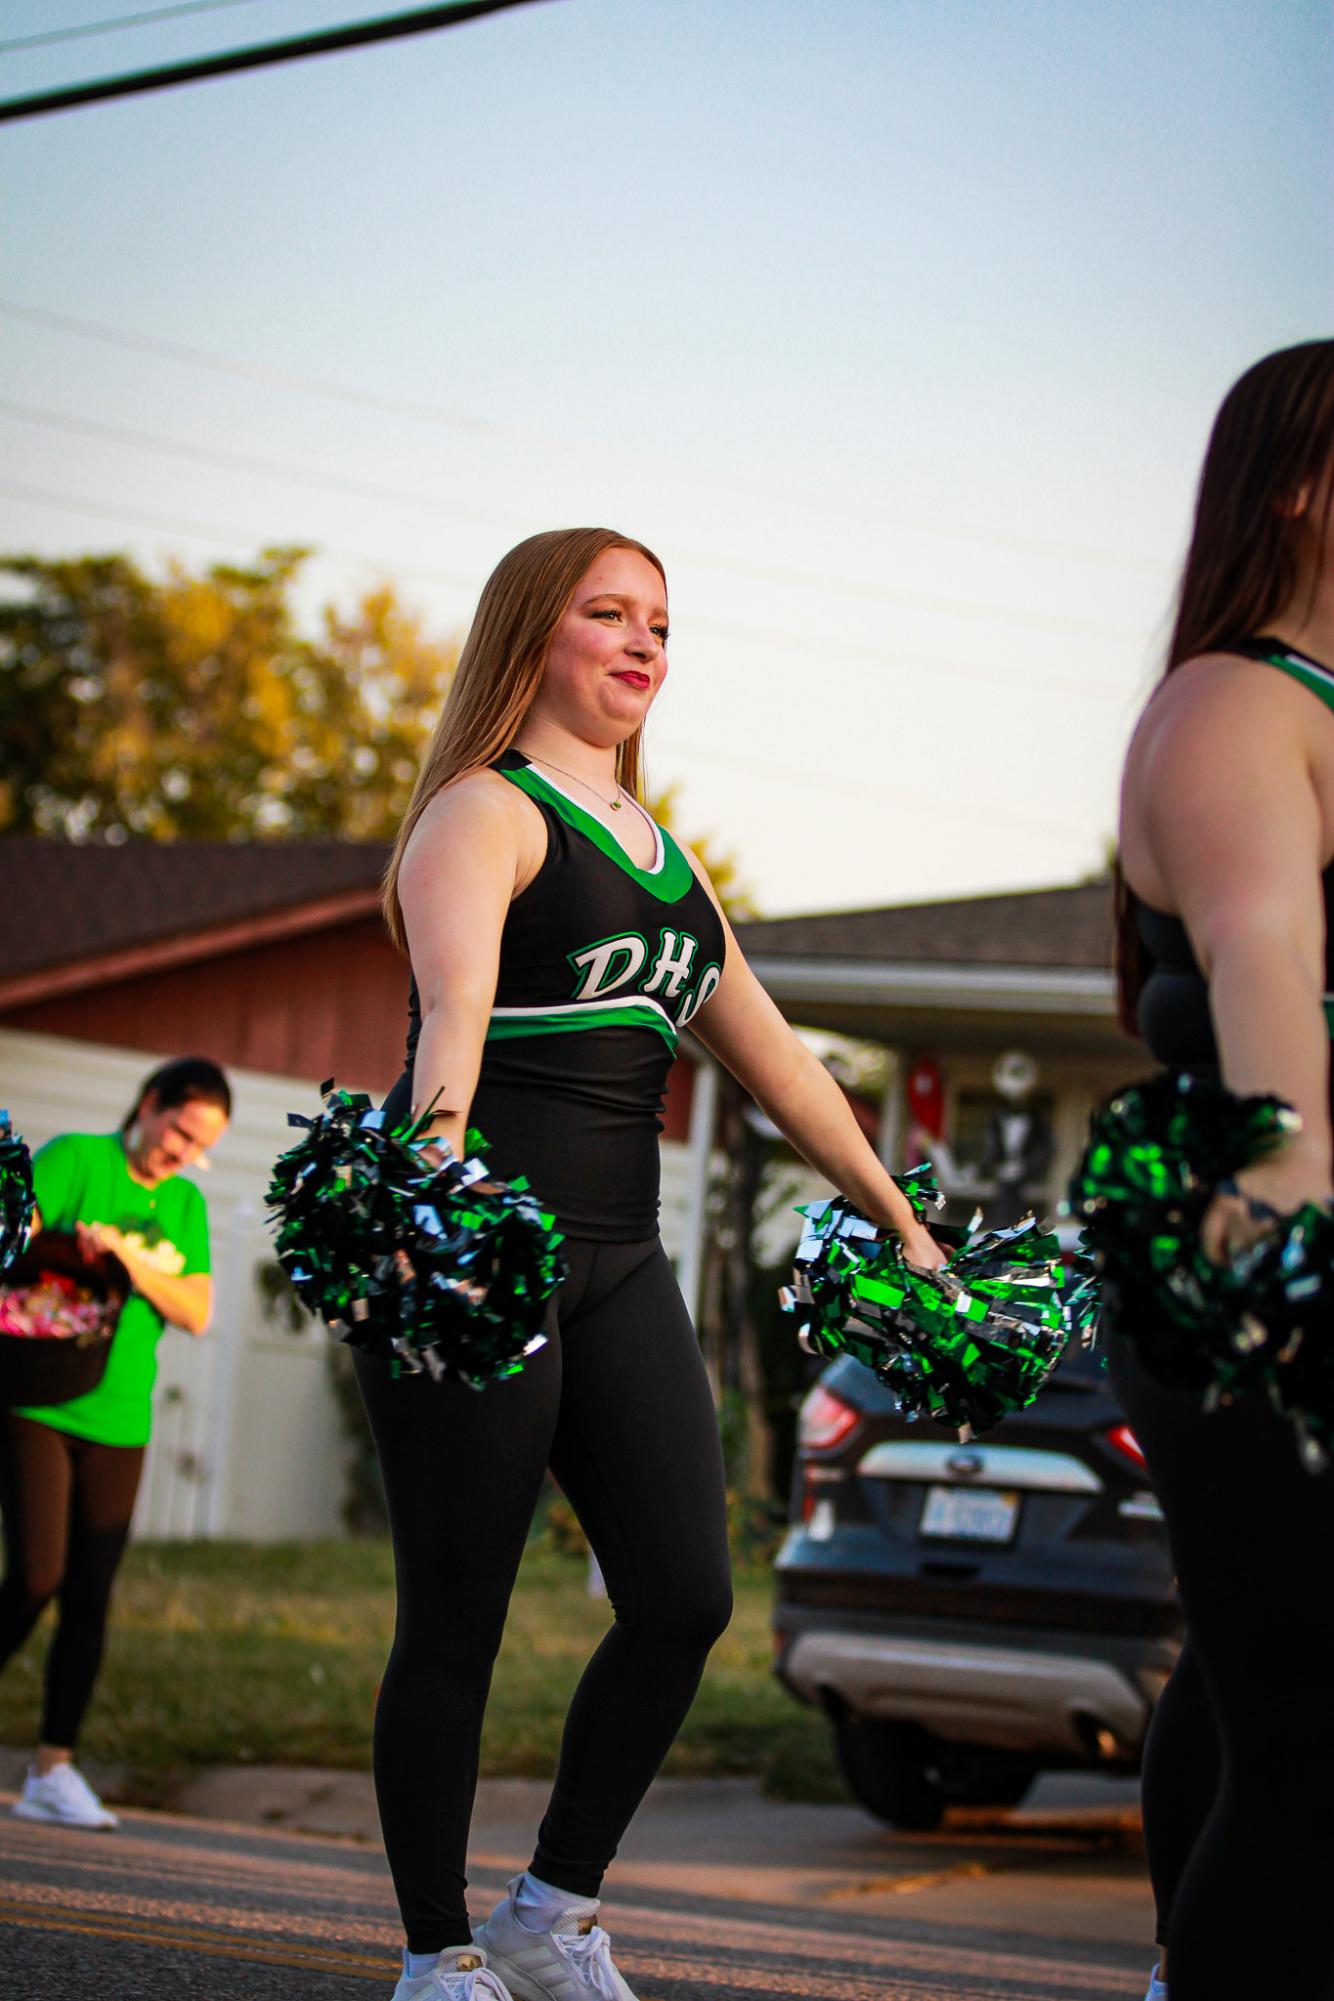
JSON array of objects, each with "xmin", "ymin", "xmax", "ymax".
[{"xmin": 18, "ymin": 1133, "xmax": 208, "ymax": 1445}]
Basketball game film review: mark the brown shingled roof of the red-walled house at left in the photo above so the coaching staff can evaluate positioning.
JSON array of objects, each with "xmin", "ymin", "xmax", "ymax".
[{"xmin": 0, "ymin": 836, "xmax": 388, "ymax": 980}]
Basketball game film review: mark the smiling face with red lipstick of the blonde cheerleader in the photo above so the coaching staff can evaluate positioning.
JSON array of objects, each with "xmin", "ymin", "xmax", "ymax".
[{"xmin": 530, "ymin": 548, "xmax": 668, "ymax": 750}]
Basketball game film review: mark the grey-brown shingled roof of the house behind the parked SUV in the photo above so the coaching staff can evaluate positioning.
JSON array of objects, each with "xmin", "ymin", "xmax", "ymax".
[{"xmin": 736, "ymin": 882, "xmax": 1112, "ymax": 970}]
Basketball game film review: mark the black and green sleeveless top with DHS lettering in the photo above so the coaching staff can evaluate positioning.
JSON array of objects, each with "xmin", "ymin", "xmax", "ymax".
[{"xmin": 386, "ymin": 750, "xmax": 724, "ymax": 1243}]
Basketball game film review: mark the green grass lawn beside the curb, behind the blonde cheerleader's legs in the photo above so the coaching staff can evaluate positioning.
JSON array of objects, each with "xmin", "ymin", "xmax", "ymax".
[{"xmin": 0, "ymin": 1541, "xmax": 844, "ymax": 1805}]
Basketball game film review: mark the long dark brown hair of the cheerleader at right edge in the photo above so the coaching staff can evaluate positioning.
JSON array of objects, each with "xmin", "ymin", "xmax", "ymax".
[{"xmin": 1114, "ymin": 340, "xmax": 1334, "ymax": 1035}]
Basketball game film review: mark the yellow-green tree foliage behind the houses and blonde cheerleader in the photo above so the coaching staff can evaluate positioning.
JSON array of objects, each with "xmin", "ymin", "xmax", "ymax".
[{"xmin": 0, "ymin": 548, "xmax": 748, "ymax": 914}]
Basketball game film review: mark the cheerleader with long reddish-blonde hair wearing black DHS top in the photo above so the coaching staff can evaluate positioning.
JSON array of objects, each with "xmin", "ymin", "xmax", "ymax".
[{"xmin": 358, "ymin": 528, "xmax": 942, "ymax": 2001}]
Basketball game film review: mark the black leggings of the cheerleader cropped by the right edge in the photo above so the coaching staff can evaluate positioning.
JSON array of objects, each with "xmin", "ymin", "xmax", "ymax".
[{"xmin": 1110, "ymin": 1337, "xmax": 1334, "ymax": 2001}]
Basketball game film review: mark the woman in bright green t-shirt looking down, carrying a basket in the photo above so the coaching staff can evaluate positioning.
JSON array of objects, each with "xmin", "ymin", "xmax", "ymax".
[{"xmin": 0, "ymin": 1057, "xmax": 232, "ymax": 1827}]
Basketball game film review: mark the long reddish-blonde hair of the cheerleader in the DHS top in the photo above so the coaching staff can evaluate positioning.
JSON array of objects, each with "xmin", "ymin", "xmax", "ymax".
[{"xmin": 382, "ymin": 528, "xmax": 666, "ymax": 950}]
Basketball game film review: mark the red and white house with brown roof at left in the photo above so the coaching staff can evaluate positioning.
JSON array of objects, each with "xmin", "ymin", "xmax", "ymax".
[{"xmin": 0, "ymin": 838, "xmax": 712, "ymax": 1537}]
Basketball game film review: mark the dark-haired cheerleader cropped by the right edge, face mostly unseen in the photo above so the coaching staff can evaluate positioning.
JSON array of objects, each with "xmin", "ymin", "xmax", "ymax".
[{"xmin": 1112, "ymin": 340, "xmax": 1334, "ymax": 2001}]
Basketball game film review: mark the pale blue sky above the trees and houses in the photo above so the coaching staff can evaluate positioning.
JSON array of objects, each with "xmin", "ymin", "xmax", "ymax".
[{"xmin": 0, "ymin": 0, "xmax": 1334, "ymax": 910}]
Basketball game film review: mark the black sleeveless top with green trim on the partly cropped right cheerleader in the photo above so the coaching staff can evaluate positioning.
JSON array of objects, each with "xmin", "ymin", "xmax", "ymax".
[{"xmin": 1134, "ymin": 638, "xmax": 1334, "ymax": 1073}]
